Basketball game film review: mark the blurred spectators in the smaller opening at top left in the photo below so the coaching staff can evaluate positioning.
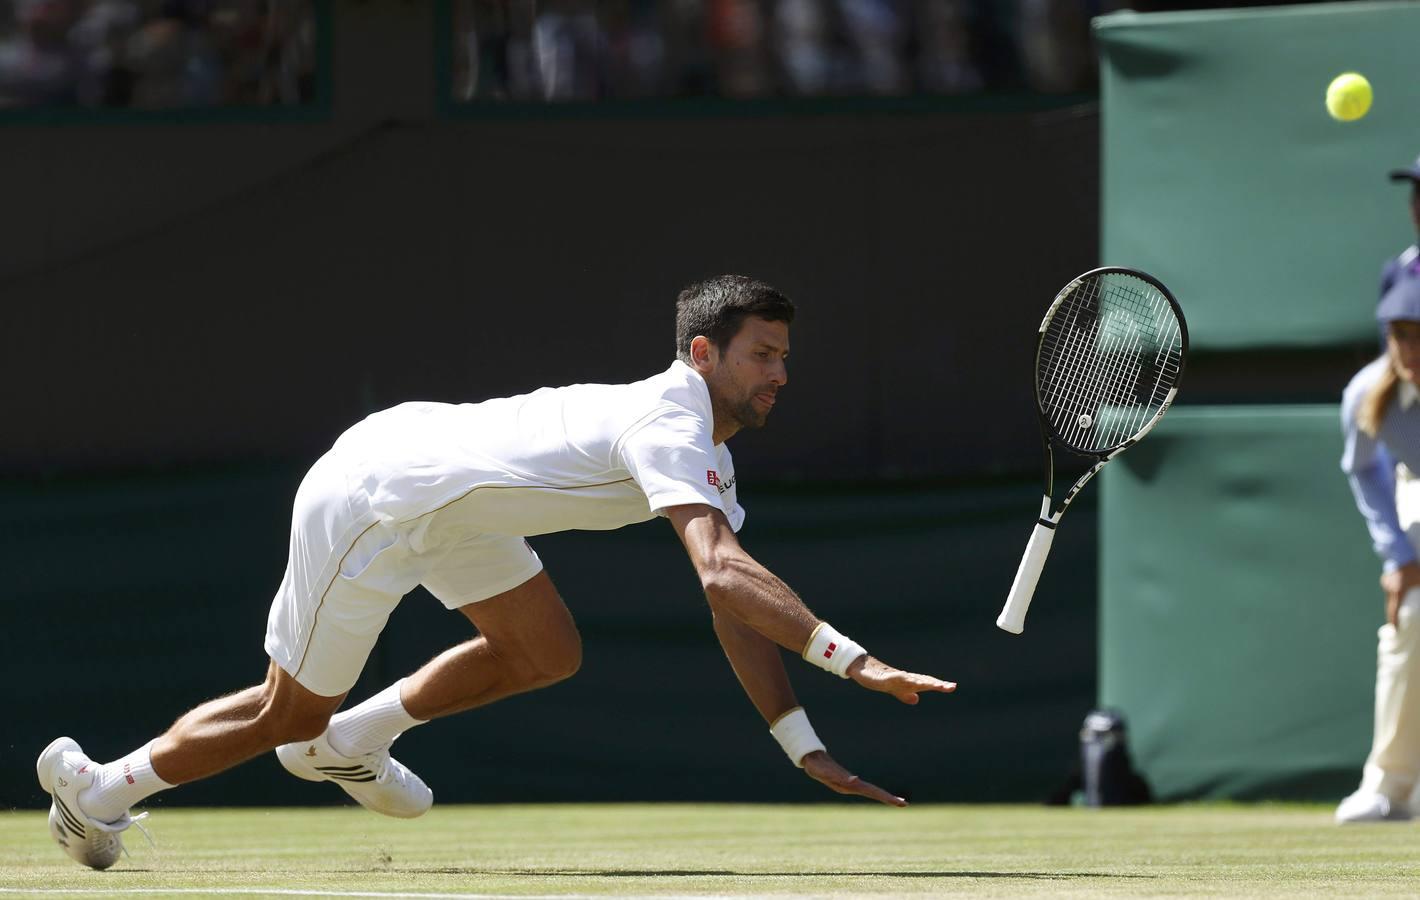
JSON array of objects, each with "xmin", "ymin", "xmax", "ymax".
[{"xmin": 0, "ymin": 0, "xmax": 315, "ymax": 109}]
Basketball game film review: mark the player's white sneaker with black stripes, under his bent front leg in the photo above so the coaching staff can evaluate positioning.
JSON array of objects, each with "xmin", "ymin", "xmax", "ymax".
[{"xmin": 275, "ymin": 731, "xmax": 435, "ymax": 819}]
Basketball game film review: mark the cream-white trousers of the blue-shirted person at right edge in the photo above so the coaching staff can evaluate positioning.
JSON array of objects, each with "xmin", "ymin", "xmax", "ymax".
[{"xmin": 1360, "ymin": 466, "xmax": 1420, "ymax": 803}]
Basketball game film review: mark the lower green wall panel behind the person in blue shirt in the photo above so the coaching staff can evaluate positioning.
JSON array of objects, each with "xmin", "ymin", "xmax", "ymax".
[{"xmin": 1101, "ymin": 405, "xmax": 1383, "ymax": 799}]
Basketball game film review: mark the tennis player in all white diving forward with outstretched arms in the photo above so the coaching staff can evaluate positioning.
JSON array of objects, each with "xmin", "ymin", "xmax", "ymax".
[{"xmin": 37, "ymin": 275, "xmax": 956, "ymax": 869}]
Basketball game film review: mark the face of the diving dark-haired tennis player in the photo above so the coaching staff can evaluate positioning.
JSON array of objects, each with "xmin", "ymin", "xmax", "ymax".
[{"xmin": 706, "ymin": 317, "xmax": 790, "ymax": 430}]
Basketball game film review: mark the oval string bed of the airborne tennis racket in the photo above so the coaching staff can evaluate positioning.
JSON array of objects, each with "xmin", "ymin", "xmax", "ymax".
[{"xmin": 1037, "ymin": 273, "xmax": 1183, "ymax": 451}]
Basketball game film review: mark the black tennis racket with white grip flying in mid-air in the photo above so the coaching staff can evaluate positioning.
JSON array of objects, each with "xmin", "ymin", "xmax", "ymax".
[{"xmin": 995, "ymin": 267, "xmax": 1189, "ymax": 635}]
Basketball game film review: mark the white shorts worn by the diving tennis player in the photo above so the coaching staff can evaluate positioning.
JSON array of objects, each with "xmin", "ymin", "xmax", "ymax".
[{"xmin": 266, "ymin": 450, "xmax": 542, "ymax": 697}]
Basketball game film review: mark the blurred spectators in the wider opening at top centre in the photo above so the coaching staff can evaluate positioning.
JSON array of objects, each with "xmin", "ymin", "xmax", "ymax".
[{"xmin": 453, "ymin": 0, "xmax": 1129, "ymax": 101}]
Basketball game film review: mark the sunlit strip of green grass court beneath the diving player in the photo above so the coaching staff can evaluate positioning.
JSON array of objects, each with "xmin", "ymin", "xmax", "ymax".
[{"xmin": 0, "ymin": 802, "xmax": 1420, "ymax": 900}]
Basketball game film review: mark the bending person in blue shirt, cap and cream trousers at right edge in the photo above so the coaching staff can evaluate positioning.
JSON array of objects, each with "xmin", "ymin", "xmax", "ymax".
[{"xmin": 1336, "ymin": 277, "xmax": 1420, "ymax": 823}]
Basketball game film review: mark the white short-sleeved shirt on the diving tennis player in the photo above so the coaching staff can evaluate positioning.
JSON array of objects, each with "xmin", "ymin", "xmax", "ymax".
[{"xmin": 335, "ymin": 361, "xmax": 744, "ymax": 545}]
